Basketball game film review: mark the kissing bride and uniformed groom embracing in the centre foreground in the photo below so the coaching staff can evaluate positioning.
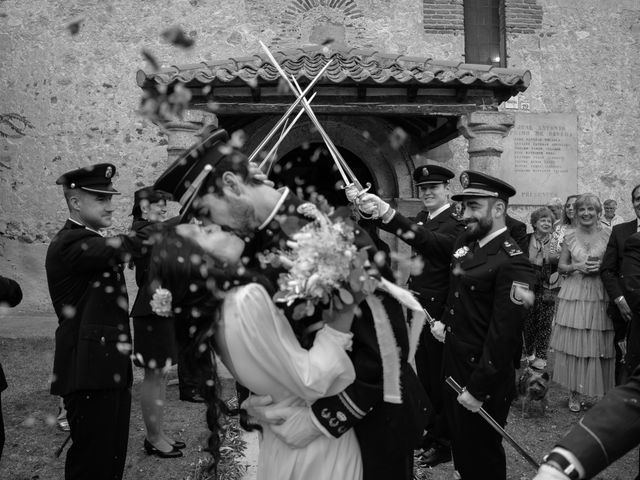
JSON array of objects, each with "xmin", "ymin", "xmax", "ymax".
[{"xmin": 151, "ymin": 130, "xmax": 428, "ymax": 480}]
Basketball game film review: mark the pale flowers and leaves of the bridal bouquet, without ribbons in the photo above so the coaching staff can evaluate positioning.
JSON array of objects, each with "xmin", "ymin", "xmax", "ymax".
[{"xmin": 274, "ymin": 203, "xmax": 378, "ymax": 320}]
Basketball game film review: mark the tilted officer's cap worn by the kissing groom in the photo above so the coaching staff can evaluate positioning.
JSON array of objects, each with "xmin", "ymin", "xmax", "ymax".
[{"xmin": 153, "ymin": 129, "xmax": 232, "ymax": 221}]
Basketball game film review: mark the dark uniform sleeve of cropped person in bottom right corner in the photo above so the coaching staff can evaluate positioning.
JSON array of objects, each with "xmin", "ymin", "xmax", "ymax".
[{"xmin": 558, "ymin": 368, "xmax": 640, "ymax": 478}]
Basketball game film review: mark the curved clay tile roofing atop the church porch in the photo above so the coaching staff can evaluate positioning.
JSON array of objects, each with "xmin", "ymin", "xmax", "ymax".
[{"xmin": 137, "ymin": 45, "xmax": 531, "ymax": 91}]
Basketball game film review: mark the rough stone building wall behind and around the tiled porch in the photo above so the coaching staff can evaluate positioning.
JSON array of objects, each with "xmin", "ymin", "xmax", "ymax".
[{"xmin": 0, "ymin": 0, "xmax": 640, "ymax": 236}]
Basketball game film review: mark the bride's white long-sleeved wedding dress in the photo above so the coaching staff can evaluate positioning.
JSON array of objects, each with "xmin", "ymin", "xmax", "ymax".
[{"xmin": 218, "ymin": 284, "xmax": 362, "ymax": 480}]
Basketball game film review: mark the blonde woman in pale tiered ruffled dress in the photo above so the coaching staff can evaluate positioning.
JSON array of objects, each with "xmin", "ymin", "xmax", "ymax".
[{"xmin": 551, "ymin": 193, "xmax": 615, "ymax": 412}]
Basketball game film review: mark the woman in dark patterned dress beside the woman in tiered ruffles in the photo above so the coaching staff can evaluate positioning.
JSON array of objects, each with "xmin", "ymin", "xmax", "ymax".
[{"xmin": 524, "ymin": 207, "xmax": 558, "ymax": 370}]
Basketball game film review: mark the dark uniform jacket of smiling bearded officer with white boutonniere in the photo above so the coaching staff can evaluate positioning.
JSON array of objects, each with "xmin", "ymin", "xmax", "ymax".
[{"xmin": 442, "ymin": 232, "xmax": 534, "ymax": 401}]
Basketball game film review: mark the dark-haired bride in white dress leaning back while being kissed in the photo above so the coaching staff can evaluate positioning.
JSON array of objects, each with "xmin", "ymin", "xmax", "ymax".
[{"xmin": 151, "ymin": 225, "xmax": 362, "ymax": 480}]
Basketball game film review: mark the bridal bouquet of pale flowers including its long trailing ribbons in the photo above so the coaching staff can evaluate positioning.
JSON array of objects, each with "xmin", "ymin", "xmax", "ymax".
[{"xmin": 274, "ymin": 203, "xmax": 425, "ymax": 404}]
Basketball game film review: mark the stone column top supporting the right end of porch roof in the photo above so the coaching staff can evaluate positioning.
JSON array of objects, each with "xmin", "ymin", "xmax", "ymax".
[{"xmin": 458, "ymin": 111, "xmax": 514, "ymax": 177}]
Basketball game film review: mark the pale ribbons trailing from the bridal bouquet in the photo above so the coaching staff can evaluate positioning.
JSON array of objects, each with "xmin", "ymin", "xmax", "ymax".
[{"xmin": 366, "ymin": 278, "xmax": 426, "ymax": 404}]
